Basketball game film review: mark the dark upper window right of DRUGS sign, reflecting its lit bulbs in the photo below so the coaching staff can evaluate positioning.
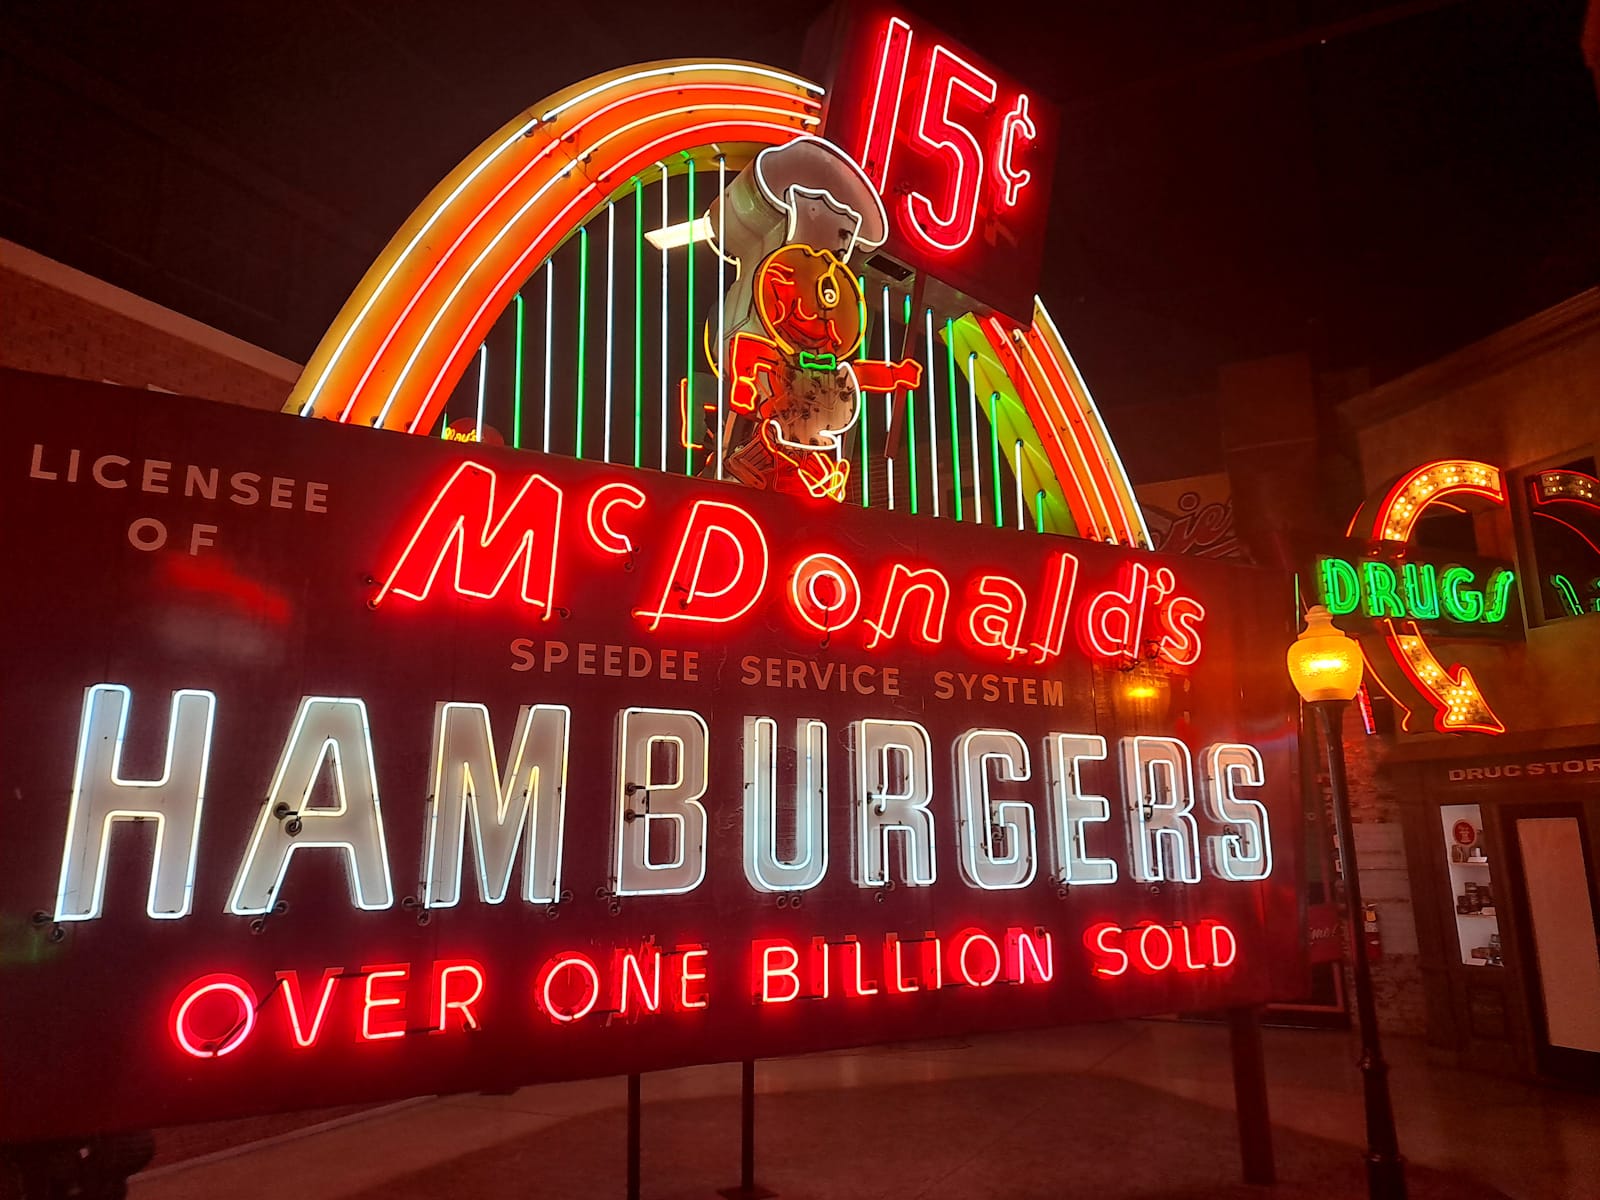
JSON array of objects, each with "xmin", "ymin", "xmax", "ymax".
[{"xmin": 1525, "ymin": 456, "xmax": 1600, "ymax": 624}]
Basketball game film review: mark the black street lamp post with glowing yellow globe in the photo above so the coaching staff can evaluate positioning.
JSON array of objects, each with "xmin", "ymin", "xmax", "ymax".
[{"xmin": 1288, "ymin": 605, "xmax": 1406, "ymax": 1200}]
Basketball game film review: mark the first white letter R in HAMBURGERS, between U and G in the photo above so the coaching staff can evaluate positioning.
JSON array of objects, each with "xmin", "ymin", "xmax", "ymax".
[{"xmin": 851, "ymin": 720, "xmax": 938, "ymax": 888}]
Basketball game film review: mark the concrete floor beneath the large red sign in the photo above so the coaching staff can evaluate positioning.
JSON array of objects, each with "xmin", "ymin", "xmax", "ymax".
[{"xmin": 130, "ymin": 1021, "xmax": 1600, "ymax": 1200}]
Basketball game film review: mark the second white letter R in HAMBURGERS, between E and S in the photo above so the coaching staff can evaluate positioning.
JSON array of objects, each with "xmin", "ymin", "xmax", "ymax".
[{"xmin": 1122, "ymin": 738, "xmax": 1200, "ymax": 883}]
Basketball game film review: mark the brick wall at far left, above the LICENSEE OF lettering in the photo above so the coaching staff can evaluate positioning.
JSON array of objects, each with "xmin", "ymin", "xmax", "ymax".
[{"xmin": 0, "ymin": 243, "xmax": 299, "ymax": 410}]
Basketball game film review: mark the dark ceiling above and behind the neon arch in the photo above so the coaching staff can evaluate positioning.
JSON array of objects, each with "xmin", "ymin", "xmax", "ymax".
[{"xmin": 0, "ymin": 0, "xmax": 1600, "ymax": 405}]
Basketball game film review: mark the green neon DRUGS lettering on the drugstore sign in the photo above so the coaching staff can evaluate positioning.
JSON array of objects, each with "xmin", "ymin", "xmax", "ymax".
[{"xmin": 1317, "ymin": 555, "xmax": 1517, "ymax": 624}]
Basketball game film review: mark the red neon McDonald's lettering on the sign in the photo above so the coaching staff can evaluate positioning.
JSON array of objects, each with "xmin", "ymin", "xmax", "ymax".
[{"xmin": 370, "ymin": 462, "xmax": 1206, "ymax": 666}]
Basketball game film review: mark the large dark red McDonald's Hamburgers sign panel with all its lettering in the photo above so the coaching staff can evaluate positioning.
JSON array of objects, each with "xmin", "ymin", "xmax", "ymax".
[{"xmin": 0, "ymin": 373, "xmax": 1304, "ymax": 1141}]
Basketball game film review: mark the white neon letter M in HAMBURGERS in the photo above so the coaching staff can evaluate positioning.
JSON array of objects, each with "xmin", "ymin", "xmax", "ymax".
[{"xmin": 422, "ymin": 702, "xmax": 573, "ymax": 909}]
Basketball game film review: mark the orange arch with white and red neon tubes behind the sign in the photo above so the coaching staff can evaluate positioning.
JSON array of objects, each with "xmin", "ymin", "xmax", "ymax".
[{"xmin": 285, "ymin": 59, "xmax": 1149, "ymax": 546}]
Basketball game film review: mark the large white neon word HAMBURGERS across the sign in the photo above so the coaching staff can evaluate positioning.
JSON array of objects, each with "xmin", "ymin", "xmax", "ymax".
[{"xmin": 54, "ymin": 683, "xmax": 1272, "ymax": 922}]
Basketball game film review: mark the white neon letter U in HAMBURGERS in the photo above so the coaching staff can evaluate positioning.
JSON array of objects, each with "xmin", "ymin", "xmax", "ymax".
[{"xmin": 744, "ymin": 717, "xmax": 827, "ymax": 891}]
